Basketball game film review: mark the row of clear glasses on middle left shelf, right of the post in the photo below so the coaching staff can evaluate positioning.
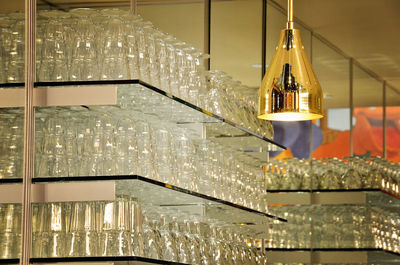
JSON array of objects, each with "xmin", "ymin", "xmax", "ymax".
[{"xmin": 35, "ymin": 107, "xmax": 266, "ymax": 212}]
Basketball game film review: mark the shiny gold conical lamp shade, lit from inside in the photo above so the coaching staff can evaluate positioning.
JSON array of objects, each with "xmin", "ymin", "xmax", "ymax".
[{"xmin": 258, "ymin": 28, "xmax": 323, "ymax": 121}]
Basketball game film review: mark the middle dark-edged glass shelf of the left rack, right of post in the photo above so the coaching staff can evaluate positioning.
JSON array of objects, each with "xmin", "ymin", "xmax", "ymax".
[{"xmin": 32, "ymin": 175, "xmax": 286, "ymax": 236}]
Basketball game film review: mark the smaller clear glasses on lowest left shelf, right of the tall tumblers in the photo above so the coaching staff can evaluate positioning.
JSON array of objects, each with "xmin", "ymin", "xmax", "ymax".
[{"xmin": 142, "ymin": 206, "xmax": 266, "ymax": 264}]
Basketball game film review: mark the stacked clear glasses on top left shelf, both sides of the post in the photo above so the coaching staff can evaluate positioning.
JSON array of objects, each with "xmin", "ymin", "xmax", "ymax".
[{"xmin": 0, "ymin": 8, "xmax": 273, "ymax": 138}]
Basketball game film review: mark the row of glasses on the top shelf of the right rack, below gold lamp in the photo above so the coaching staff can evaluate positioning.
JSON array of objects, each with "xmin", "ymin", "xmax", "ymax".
[{"xmin": 266, "ymin": 157, "xmax": 400, "ymax": 195}]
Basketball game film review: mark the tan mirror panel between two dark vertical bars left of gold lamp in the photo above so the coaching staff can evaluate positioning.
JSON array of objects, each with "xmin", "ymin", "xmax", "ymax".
[{"xmin": 210, "ymin": 0, "xmax": 262, "ymax": 87}]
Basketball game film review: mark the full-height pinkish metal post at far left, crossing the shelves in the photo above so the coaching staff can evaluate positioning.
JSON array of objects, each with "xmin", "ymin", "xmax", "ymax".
[{"xmin": 20, "ymin": 0, "xmax": 36, "ymax": 265}]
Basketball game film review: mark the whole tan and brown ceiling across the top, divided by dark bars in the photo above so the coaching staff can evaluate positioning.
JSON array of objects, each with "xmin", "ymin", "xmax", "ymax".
[{"xmin": 0, "ymin": 0, "xmax": 400, "ymax": 107}]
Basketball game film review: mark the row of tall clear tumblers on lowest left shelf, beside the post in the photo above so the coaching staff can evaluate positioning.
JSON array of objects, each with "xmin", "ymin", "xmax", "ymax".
[{"xmin": 32, "ymin": 196, "xmax": 140, "ymax": 257}]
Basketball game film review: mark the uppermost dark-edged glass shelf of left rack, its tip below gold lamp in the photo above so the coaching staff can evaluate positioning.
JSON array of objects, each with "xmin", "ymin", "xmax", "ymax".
[{"xmin": 30, "ymin": 80, "xmax": 286, "ymax": 156}]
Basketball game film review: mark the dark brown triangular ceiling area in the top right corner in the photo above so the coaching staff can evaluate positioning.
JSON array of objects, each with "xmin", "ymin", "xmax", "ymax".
[{"xmin": 276, "ymin": 0, "xmax": 400, "ymax": 92}]
